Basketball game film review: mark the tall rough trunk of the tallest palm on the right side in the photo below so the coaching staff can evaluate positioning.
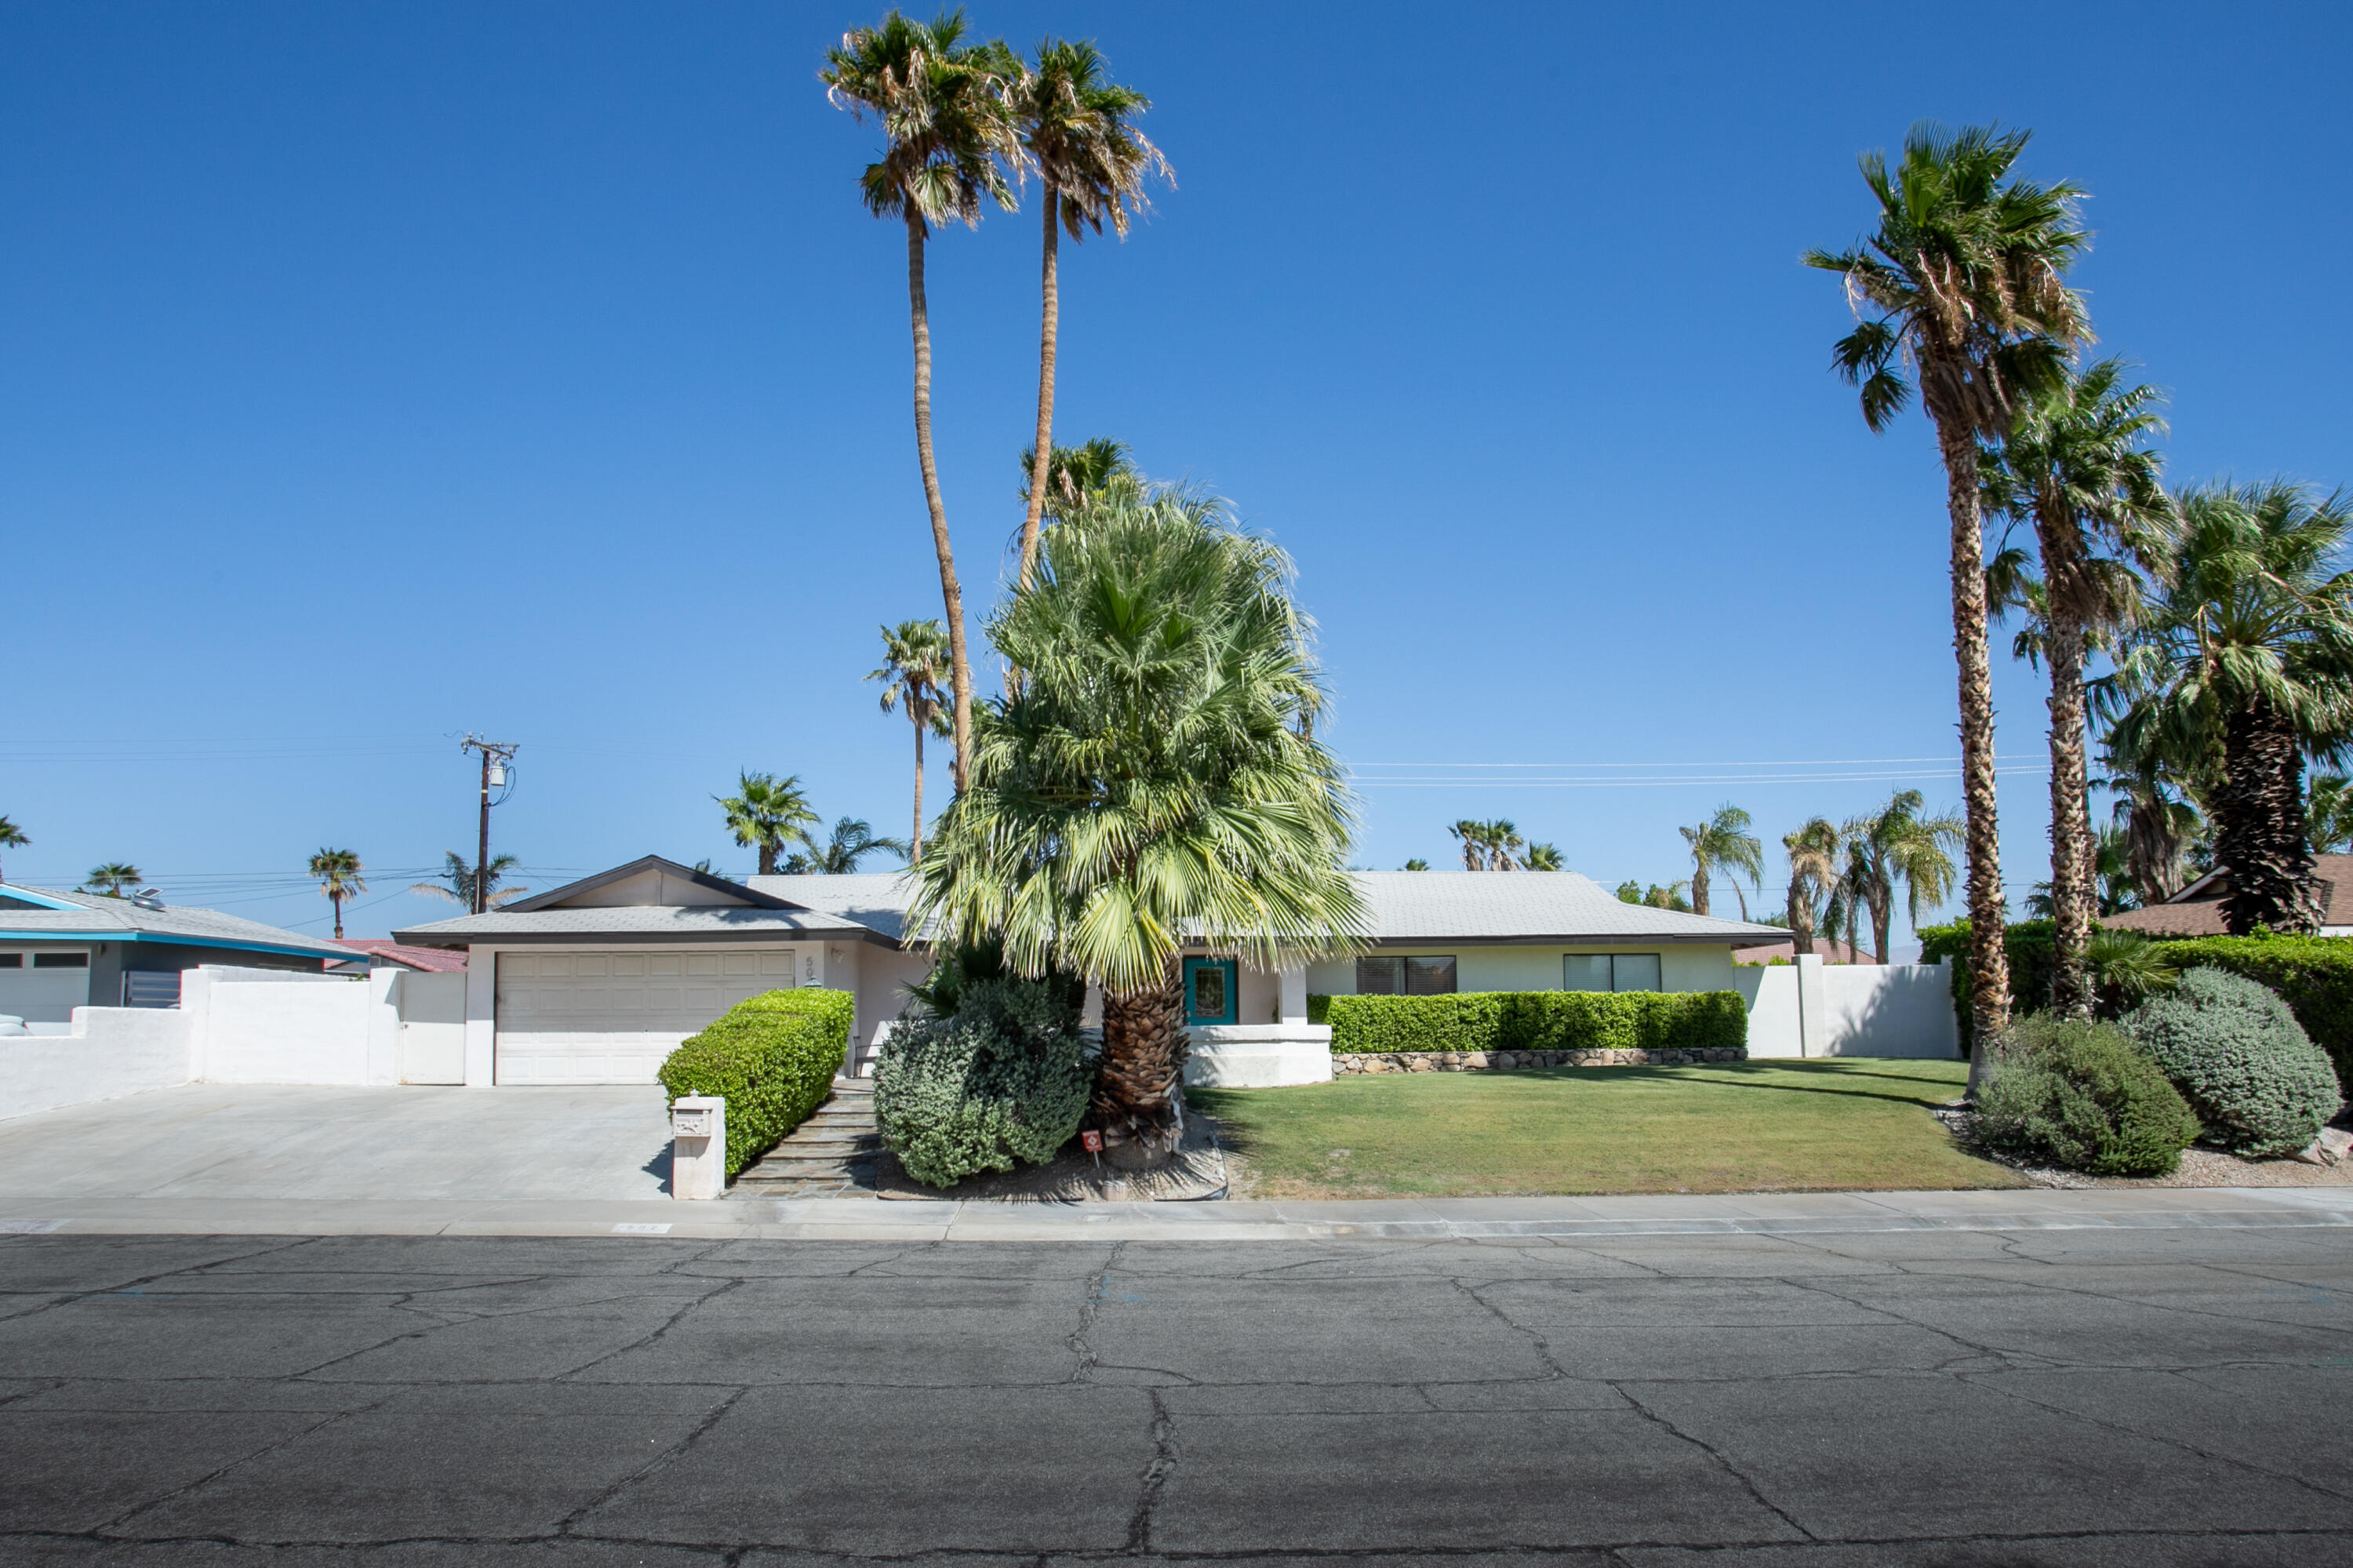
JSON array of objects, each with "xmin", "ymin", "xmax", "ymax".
[{"xmin": 1937, "ymin": 414, "xmax": 2009, "ymax": 1073}]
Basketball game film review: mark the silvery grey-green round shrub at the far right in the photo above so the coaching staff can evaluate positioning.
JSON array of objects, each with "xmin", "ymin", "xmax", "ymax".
[{"xmin": 2125, "ymin": 970, "xmax": 2344, "ymax": 1156}]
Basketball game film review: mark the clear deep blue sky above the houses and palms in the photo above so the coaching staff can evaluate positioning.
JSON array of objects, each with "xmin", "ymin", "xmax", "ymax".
[{"xmin": 0, "ymin": 0, "xmax": 2353, "ymax": 935}]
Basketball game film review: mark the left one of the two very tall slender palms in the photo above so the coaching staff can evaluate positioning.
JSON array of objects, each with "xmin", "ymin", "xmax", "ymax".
[{"xmin": 819, "ymin": 9, "xmax": 1021, "ymax": 789}]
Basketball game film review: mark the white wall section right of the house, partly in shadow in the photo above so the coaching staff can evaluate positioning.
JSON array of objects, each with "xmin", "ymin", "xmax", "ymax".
[{"xmin": 1739, "ymin": 956, "xmax": 1960, "ymax": 1060}]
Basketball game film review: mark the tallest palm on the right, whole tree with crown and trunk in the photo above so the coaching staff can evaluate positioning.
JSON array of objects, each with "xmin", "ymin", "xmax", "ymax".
[{"xmin": 1805, "ymin": 125, "xmax": 2092, "ymax": 1045}]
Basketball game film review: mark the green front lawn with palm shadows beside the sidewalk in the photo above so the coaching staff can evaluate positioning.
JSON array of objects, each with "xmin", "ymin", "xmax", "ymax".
[{"xmin": 1186, "ymin": 1060, "xmax": 2026, "ymax": 1199}]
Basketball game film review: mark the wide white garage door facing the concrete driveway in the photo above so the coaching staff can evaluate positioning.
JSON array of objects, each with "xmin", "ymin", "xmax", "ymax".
[{"xmin": 496, "ymin": 949, "xmax": 795, "ymax": 1083}]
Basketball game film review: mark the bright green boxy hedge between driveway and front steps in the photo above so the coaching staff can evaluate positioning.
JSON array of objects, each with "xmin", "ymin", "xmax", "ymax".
[{"xmin": 654, "ymin": 987, "xmax": 856, "ymax": 1175}]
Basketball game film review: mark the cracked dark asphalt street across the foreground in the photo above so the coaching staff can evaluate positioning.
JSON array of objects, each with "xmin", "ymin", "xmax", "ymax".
[{"xmin": 0, "ymin": 1227, "xmax": 2353, "ymax": 1568}]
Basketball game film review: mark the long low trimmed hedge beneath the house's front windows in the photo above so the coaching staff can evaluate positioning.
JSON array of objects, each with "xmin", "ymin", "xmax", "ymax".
[{"xmin": 1308, "ymin": 991, "xmax": 1748, "ymax": 1055}]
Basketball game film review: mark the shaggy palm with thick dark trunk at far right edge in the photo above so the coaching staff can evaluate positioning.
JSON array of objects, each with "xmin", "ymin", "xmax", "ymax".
[{"xmin": 2113, "ymin": 480, "xmax": 2353, "ymax": 937}]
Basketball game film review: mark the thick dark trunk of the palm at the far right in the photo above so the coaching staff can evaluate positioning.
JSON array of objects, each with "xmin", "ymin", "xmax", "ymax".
[{"xmin": 2214, "ymin": 699, "xmax": 2320, "ymax": 937}]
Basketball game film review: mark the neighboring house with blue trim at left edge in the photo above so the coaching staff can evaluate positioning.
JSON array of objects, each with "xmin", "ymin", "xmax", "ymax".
[{"xmin": 0, "ymin": 883, "xmax": 351, "ymax": 1024}]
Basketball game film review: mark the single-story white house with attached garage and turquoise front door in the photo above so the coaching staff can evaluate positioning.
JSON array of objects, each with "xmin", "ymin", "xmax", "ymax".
[{"xmin": 393, "ymin": 855, "xmax": 1788, "ymax": 1086}]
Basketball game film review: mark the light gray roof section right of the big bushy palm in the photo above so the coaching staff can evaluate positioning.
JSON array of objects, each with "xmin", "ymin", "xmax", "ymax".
[{"xmin": 1355, "ymin": 871, "xmax": 1788, "ymax": 947}]
